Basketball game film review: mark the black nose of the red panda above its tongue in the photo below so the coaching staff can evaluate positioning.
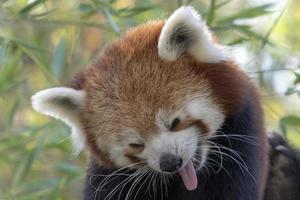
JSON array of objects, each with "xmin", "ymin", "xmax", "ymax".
[{"xmin": 159, "ymin": 154, "xmax": 182, "ymax": 172}]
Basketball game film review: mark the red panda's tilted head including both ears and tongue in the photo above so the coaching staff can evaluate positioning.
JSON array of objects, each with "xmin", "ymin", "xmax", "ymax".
[{"xmin": 32, "ymin": 7, "xmax": 250, "ymax": 191}]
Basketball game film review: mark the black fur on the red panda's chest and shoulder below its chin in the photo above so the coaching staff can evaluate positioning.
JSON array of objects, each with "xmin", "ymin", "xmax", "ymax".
[{"xmin": 85, "ymin": 94, "xmax": 265, "ymax": 200}]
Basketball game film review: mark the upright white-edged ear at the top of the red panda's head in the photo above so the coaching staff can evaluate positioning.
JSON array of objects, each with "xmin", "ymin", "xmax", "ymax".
[{"xmin": 158, "ymin": 7, "xmax": 228, "ymax": 63}]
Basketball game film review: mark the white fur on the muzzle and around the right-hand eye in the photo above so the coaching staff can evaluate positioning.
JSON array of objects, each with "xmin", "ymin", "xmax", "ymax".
[{"xmin": 142, "ymin": 93, "xmax": 224, "ymax": 170}]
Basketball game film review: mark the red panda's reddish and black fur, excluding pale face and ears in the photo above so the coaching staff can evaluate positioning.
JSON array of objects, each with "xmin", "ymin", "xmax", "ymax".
[{"xmin": 79, "ymin": 18, "xmax": 267, "ymax": 200}]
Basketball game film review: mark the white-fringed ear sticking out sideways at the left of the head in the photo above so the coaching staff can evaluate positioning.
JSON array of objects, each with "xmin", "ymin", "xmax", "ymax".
[{"xmin": 31, "ymin": 87, "xmax": 85, "ymax": 153}]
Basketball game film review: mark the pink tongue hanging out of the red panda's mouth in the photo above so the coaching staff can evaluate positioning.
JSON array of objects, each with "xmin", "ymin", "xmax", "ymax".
[{"xmin": 179, "ymin": 160, "xmax": 198, "ymax": 191}]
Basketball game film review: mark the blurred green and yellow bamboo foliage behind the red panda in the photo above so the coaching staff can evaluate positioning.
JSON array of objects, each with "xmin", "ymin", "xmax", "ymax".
[{"xmin": 0, "ymin": 0, "xmax": 300, "ymax": 200}]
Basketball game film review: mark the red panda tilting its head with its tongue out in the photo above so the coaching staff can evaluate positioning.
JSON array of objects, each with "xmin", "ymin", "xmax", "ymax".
[{"xmin": 32, "ymin": 7, "xmax": 268, "ymax": 200}]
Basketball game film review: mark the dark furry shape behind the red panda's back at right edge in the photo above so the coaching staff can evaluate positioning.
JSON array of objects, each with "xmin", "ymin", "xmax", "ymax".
[{"xmin": 265, "ymin": 133, "xmax": 300, "ymax": 200}]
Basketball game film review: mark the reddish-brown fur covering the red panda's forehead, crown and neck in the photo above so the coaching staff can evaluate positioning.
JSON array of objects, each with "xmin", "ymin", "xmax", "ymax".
[{"xmin": 69, "ymin": 22, "xmax": 266, "ymax": 192}]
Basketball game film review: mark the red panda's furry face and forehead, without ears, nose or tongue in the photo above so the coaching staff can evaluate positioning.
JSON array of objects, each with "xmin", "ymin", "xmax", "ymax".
[{"xmin": 82, "ymin": 41, "xmax": 224, "ymax": 171}]
